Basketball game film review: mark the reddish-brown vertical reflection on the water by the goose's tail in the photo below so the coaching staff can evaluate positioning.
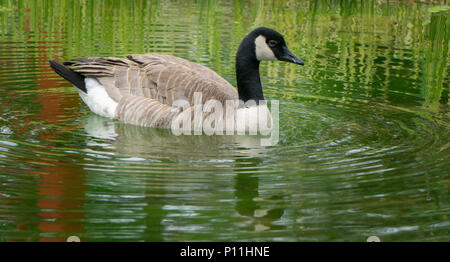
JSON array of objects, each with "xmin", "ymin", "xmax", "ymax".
[{"xmin": 36, "ymin": 52, "xmax": 86, "ymax": 241}]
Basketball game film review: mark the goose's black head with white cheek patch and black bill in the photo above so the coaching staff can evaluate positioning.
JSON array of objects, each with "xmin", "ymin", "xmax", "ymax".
[{"xmin": 238, "ymin": 27, "xmax": 303, "ymax": 65}]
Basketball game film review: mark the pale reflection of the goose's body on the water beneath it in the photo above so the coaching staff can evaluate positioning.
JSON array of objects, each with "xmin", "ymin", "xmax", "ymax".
[{"xmin": 83, "ymin": 114, "xmax": 271, "ymax": 161}]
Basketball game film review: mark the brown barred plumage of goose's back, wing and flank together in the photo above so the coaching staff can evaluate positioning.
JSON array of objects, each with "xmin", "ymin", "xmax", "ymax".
[{"xmin": 64, "ymin": 53, "xmax": 238, "ymax": 128}]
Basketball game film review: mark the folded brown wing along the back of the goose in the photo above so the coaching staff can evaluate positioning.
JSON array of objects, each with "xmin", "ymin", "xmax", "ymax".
[{"xmin": 65, "ymin": 53, "xmax": 238, "ymax": 106}]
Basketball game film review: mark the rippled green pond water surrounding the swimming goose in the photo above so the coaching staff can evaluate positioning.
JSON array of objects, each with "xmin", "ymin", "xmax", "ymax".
[{"xmin": 0, "ymin": 0, "xmax": 450, "ymax": 241}]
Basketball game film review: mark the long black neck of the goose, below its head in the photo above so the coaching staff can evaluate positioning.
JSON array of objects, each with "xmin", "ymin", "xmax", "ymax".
[{"xmin": 236, "ymin": 35, "xmax": 264, "ymax": 104}]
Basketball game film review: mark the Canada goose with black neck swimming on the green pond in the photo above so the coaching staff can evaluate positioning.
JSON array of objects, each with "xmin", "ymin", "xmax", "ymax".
[{"xmin": 50, "ymin": 27, "xmax": 303, "ymax": 133}]
